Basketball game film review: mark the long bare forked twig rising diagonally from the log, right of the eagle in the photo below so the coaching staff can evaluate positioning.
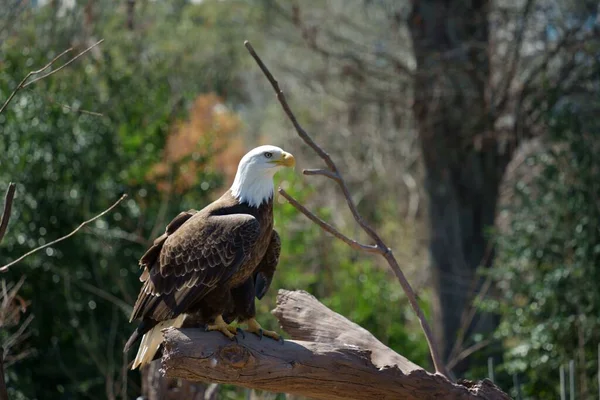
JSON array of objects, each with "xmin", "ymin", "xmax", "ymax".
[{"xmin": 244, "ymin": 41, "xmax": 448, "ymax": 377}]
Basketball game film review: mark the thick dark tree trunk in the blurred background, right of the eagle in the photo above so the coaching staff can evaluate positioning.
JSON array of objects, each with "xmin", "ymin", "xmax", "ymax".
[{"xmin": 408, "ymin": 0, "xmax": 510, "ymax": 375}]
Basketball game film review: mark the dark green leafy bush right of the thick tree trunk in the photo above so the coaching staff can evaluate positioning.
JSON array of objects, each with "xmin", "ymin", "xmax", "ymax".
[{"xmin": 482, "ymin": 102, "xmax": 600, "ymax": 398}]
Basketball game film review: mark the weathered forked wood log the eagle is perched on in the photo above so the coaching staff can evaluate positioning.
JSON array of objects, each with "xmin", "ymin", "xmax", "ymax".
[{"xmin": 162, "ymin": 290, "xmax": 509, "ymax": 400}]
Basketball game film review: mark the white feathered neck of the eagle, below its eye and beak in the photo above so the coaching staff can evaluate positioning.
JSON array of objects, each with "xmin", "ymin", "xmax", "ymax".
[{"xmin": 231, "ymin": 165, "xmax": 275, "ymax": 207}]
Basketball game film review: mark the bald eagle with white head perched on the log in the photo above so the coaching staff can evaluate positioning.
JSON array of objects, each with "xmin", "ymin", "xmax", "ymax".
[{"xmin": 124, "ymin": 146, "xmax": 295, "ymax": 369}]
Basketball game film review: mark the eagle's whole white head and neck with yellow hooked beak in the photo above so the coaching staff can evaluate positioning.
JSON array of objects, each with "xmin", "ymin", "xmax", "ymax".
[{"xmin": 231, "ymin": 145, "xmax": 296, "ymax": 207}]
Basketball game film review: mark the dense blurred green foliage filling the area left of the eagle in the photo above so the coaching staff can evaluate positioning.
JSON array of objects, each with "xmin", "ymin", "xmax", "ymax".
[{"xmin": 0, "ymin": 2, "xmax": 255, "ymax": 399}]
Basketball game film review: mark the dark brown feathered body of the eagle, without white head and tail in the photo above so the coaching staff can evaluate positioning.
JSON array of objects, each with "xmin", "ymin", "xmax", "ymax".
[{"xmin": 125, "ymin": 190, "xmax": 281, "ymax": 367}]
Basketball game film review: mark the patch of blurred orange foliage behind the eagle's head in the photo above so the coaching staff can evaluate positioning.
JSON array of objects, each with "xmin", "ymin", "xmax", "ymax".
[{"xmin": 148, "ymin": 94, "xmax": 244, "ymax": 194}]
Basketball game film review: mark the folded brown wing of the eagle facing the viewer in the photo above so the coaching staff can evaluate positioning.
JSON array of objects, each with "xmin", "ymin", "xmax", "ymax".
[{"xmin": 131, "ymin": 214, "xmax": 260, "ymax": 321}]
